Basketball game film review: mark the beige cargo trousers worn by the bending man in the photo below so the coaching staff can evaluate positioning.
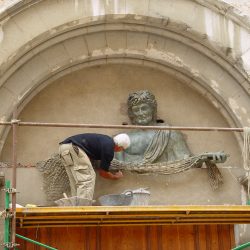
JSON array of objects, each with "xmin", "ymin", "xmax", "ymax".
[{"xmin": 59, "ymin": 143, "xmax": 96, "ymax": 200}]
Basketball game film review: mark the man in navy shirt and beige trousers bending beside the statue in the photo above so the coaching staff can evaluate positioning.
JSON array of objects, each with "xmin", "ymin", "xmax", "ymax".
[{"xmin": 59, "ymin": 133, "xmax": 130, "ymax": 200}]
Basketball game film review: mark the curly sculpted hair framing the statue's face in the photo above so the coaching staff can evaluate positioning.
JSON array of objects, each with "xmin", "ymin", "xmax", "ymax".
[{"xmin": 127, "ymin": 90, "xmax": 157, "ymax": 122}]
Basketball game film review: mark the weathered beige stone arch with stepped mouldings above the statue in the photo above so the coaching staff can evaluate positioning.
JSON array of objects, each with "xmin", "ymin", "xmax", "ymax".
[{"xmin": 0, "ymin": 0, "xmax": 250, "ymax": 152}]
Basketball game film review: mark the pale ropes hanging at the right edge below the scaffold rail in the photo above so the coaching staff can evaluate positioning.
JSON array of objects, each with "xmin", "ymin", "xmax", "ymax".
[{"xmin": 242, "ymin": 127, "xmax": 250, "ymax": 197}]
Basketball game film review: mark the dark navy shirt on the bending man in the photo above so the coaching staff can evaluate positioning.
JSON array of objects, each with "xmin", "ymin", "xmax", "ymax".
[{"xmin": 60, "ymin": 133, "xmax": 115, "ymax": 171}]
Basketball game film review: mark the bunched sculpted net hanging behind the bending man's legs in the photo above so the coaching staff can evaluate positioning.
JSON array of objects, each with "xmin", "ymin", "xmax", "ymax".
[{"xmin": 36, "ymin": 154, "xmax": 70, "ymax": 202}]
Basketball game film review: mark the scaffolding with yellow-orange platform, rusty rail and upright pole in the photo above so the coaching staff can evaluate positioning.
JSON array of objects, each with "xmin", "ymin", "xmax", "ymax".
[{"xmin": 0, "ymin": 114, "xmax": 250, "ymax": 249}]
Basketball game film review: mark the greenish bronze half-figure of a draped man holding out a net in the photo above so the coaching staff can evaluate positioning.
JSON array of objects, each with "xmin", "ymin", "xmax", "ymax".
[{"xmin": 112, "ymin": 90, "xmax": 227, "ymax": 189}]
